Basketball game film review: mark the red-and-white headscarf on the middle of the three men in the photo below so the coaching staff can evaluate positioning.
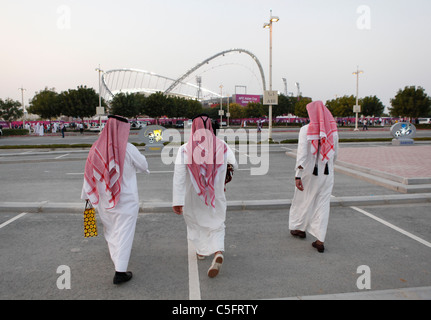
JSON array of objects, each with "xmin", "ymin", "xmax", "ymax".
[{"xmin": 185, "ymin": 116, "xmax": 227, "ymax": 208}]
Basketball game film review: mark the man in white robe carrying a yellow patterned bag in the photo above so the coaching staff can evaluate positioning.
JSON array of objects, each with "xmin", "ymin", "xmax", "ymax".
[{"xmin": 81, "ymin": 116, "xmax": 149, "ymax": 284}]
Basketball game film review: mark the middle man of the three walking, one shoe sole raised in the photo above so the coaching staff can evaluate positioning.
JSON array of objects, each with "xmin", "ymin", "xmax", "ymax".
[{"xmin": 172, "ymin": 115, "xmax": 237, "ymax": 278}]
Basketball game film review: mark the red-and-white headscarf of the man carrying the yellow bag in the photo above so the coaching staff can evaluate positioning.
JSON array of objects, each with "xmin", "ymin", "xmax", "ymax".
[{"xmin": 84, "ymin": 118, "xmax": 130, "ymax": 209}]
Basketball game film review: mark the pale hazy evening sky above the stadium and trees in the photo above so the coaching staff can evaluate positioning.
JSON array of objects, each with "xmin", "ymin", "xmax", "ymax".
[{"xmin": 0, "ymin": 0, "xmax": 431, "ymax": 112}]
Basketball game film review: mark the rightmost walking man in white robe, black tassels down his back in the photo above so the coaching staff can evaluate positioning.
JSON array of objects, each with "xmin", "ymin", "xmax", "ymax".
[{"xmin": 289, "ymin": 101, "xmax": 338, "ymax": 252}]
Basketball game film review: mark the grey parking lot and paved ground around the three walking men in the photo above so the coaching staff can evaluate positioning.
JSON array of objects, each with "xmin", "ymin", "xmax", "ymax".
[{"xmin": 0, "ymin": 136, "xmax": 431, "ymax": 301}]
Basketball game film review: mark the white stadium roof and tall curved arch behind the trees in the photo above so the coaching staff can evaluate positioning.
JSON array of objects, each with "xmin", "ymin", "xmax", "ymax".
[{"xmin": 101, "ymin": 49, "xmax": 266, "ymax": 100}]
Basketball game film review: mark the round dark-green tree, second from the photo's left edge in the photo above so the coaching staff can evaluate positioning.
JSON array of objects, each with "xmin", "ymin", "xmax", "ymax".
[{"xmin": 28, "ymin": 88, "xmax": 62, "ymax": 119}]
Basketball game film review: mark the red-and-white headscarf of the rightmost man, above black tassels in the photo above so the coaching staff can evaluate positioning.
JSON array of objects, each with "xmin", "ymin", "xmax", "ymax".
[{"xmin": 307, "ymin": 101, "xmax": 338, "ymax": 162}]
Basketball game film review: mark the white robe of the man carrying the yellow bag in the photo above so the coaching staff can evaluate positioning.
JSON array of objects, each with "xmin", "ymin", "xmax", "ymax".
[{"xmin": 81, "ymin": 143, "xmax": 149, "ymax": 272}]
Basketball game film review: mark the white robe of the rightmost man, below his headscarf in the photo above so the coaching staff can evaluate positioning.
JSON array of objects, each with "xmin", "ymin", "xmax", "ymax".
[{"xmin": 289, "ymin": 125, "xmax": 338, "ymax": 242}]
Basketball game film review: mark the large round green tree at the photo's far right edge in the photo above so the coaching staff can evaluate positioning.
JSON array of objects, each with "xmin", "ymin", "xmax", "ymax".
[{"xmin": 389, "ymin": 86, "xmax": 431, "ymax": 118}]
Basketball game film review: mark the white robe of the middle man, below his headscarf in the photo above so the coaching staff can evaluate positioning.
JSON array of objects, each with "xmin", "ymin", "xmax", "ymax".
[{"xmin": 172, "ymin": 140, "xmax": 238, "ymax": 256}]
